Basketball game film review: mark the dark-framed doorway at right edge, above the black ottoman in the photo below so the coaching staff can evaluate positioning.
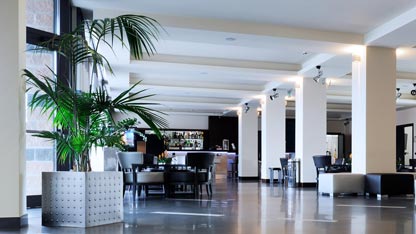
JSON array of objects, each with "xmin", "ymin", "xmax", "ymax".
[{"xmin": 396, "ymin": 124, "xmax": 414, "ymax": 166}]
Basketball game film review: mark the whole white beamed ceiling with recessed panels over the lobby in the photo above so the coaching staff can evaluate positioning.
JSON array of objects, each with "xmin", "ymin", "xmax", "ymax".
[{"xmin": 73, "ymin": 0, "xmax": 416, "ymax": 118}]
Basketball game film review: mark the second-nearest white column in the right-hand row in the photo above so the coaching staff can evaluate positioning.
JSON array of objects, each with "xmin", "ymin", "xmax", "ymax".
[{"xmin": 295, "ymin": 78, "xmax": 326, "ymax": 183}]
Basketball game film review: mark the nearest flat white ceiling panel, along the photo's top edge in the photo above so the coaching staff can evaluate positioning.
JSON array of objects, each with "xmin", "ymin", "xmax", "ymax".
[{"xmin": 74, "ymin": 0, "xmax": 415, "ymax": 33}]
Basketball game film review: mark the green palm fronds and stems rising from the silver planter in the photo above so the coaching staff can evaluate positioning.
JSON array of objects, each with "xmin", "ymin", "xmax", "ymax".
[{"xmin": 23, "ymin": 15, "xmax": 167, "ymax": 171}]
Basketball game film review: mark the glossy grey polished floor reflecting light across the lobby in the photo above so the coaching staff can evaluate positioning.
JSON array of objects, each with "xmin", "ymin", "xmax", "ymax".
[{"xmin": 0, "ymin": 179, "xmax": 416, "ymax": 234}]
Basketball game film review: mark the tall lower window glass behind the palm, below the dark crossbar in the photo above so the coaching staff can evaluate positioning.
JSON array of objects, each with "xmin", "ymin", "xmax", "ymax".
[{"xmin": 26, "ymin": 45, "xmax": 55, "ymax": 195}]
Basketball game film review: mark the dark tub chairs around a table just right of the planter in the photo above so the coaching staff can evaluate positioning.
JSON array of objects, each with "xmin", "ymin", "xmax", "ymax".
[{"xmin": 117, "ymin": 152, "xmax": 215, "ymax": 200}]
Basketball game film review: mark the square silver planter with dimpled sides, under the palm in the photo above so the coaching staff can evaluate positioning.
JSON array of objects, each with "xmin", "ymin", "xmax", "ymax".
[{"xmin": 42, "ymin": 171, "xmax": 123, "ymax": 227}]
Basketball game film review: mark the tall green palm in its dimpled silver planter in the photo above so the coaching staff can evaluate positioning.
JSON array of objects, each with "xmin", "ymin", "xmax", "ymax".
[{"xmin": 24, "ymin": 15, "xmax": 167, "ymax": 227}]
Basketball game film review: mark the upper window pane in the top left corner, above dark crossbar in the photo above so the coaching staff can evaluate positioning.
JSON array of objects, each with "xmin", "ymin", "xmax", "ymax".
[{"xmin": 26, "ymin": 0, "xmax": 55, "ymax": 33}]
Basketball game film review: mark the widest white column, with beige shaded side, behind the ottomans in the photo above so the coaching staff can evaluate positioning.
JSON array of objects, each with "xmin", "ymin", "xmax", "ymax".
[{"xmin": 352, "ymin": 47, "xmax": 396, "ymax": 173}]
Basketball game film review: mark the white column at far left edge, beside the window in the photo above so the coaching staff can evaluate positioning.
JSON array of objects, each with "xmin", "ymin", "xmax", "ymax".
[{"xmin": 0, "ymin": 0, "xmax": 26, "ymax": 223}]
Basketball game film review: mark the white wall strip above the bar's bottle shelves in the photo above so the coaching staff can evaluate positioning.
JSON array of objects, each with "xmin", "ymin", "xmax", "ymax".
[{"xmin": 115, "ymin": 113, "xmax": 208, "ymax": 130}]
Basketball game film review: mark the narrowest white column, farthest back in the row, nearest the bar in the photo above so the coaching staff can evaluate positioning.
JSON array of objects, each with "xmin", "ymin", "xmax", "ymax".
[{"xmin": 238, "ymin": 104, "xmax": 258, "ymax": 178}]
